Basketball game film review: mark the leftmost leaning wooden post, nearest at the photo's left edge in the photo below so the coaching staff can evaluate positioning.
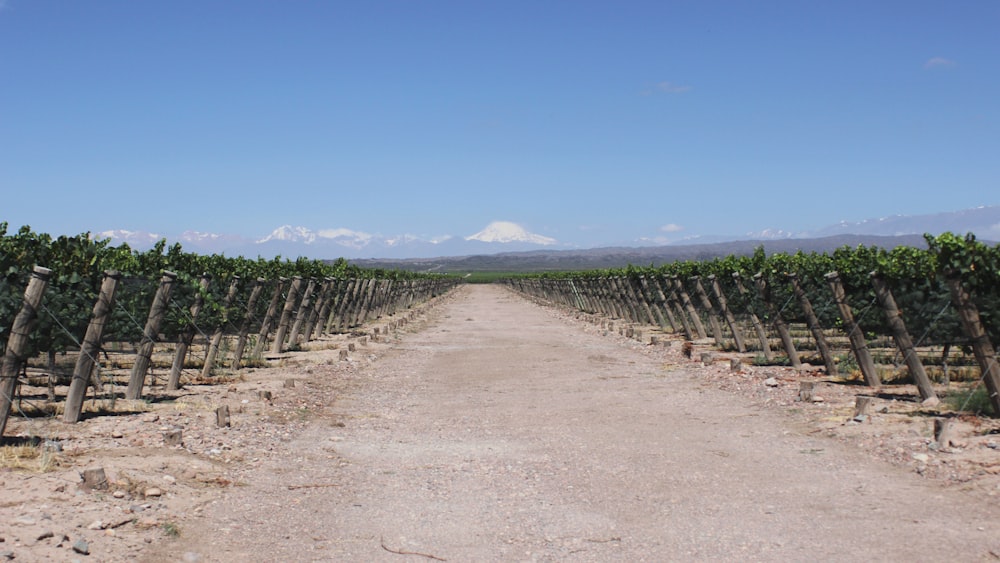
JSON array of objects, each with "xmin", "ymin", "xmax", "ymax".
[{"xmin": 0, "ymin": 266, "xmax": 52, "ymax": 436}]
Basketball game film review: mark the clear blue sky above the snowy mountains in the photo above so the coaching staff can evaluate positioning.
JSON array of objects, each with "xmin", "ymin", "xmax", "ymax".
[{"xmin": 0, "ymin": 0, "xmax": 1000, "ymax": 246}]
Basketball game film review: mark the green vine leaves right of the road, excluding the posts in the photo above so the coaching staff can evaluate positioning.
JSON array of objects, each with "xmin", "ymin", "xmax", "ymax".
[{"xmin": 504, "ymin": 233, "xmax": 1000, "ymax": 356}]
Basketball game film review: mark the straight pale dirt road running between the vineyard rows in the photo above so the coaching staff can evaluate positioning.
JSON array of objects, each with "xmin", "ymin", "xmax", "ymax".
[{"xmin": 149, "ymin": 286, "xmax": 1000, "ymax": 561}]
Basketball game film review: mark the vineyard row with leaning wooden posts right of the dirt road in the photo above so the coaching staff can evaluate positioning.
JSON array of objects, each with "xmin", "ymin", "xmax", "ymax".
[{"xmin": 505, "ymin": 234, "xmax": 1000, "ymax": 413}]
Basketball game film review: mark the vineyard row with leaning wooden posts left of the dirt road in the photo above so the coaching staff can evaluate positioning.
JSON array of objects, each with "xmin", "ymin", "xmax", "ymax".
[{"xmin": 0, "ymin": 224, "xmax": 458, "ymax": 436}]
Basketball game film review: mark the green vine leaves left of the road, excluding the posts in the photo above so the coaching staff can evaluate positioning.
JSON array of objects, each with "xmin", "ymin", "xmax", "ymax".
[{"xmin": 0, "ymin": 223, "xmax": 446, "ymax": 355}]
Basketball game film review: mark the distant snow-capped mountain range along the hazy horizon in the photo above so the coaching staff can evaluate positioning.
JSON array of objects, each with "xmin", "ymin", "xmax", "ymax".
[{"xmin": 95, "ymin": 206, "xmax": 1000, "ymax": 268}]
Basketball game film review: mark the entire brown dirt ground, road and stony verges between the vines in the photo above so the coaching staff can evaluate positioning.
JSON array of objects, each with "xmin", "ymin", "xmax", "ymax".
[{"xmin": 0, "ymin": 285, "xmax": 1000, "ymax": 562}]
